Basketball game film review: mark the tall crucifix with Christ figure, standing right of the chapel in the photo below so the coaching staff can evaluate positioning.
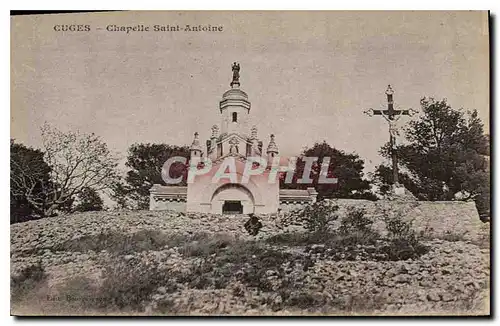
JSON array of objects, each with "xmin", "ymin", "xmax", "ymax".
[{"xmin": 364, "ymin": 85, "xmax": 417, "ymax": 187}]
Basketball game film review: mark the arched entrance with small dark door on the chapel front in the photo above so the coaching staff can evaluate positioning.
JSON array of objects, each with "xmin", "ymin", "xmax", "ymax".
[{"xmin": 211, "ymin": 184, "xmax": 255, "ymax": 214}]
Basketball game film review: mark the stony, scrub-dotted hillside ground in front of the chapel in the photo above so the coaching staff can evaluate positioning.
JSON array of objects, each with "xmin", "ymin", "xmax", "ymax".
[{"xmin": 11, "ymin": 211, "xmax": 490, "ymax": 315}]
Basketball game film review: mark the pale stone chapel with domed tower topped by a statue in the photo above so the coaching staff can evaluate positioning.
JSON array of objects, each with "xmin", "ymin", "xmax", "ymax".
[{"xmin": 150, "ymin": 62, "xmax": 317, "ymax": 214}]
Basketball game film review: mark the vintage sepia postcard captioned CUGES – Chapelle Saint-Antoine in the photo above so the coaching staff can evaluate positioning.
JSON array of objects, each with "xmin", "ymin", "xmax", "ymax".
[{"xmin": 10, "ymin": 11, "xmax": 490, "ymax": 316}]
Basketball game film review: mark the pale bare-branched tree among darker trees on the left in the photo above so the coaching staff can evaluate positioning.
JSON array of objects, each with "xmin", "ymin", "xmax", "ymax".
[{"xmin": 11, "ymin": 124, "xmax": 118, "ymax": 217}]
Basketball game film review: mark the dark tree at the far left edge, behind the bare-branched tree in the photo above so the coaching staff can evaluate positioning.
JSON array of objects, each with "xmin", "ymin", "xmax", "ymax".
[{"xmin": 10, "ymin": 140, "xmax": 50, "ymax": 223}]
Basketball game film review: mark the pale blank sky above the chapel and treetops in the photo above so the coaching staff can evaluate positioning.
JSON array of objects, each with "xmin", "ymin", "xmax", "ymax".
[{"xmin": 11, "ymin": 11, "xmax": 489, "ymax": 172}]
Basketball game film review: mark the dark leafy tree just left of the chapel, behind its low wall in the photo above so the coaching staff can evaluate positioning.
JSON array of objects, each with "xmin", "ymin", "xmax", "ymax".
[{"xmin": 113, "ymin": 143, "xmax": 189, "ymax": 209}]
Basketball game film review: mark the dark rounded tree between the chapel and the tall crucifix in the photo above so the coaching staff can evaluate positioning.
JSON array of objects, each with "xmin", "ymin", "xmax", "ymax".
[{"xmin": 280, "ymin": 141, "xmax": 376, "ymax": 200}]
